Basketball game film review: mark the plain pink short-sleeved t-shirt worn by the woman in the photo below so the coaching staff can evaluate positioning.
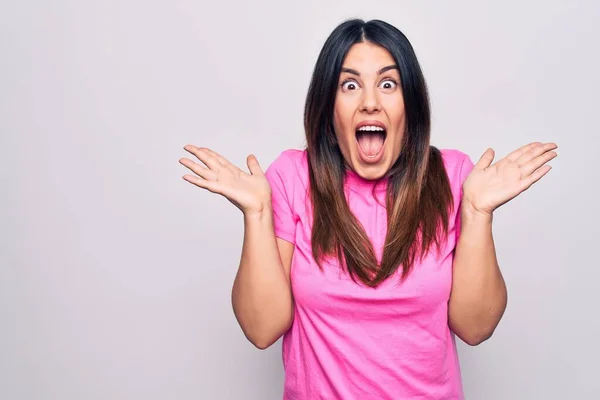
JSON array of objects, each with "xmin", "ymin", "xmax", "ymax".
[{"xmin": 266, "ymin": 150, "xmax": 473, "ymax": 400}]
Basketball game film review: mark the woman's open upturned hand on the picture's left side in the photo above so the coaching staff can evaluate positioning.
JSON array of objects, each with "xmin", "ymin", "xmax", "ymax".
[{"xmin": 179, "ymin": 145, "xmax": 271, "ymax": 216}]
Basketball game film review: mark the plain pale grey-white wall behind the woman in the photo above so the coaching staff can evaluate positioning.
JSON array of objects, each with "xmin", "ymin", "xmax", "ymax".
[{"xmin": 0, "ymin": 0, "xmax": 600, "ymax": 400}]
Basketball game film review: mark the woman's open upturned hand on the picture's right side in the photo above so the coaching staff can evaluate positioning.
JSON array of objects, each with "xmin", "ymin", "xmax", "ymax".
[{"xmin": 462, "ymin": 142, "xmax": 558, "ymax": 215}]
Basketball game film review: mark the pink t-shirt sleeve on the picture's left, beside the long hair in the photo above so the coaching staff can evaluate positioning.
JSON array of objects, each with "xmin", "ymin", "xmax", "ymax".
[{"xmin": 265, "ymin": 153, "xmax": 296, "ymax": 244}]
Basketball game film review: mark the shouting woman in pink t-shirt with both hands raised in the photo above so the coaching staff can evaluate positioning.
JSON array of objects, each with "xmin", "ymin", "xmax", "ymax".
[{"xmin": 181, "ymin": 20, "xmax": 556, "ymax": 400}]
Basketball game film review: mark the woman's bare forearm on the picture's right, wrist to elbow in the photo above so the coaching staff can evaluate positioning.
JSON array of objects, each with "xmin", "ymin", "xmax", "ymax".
[{"xmin": 449, "ymin": 207, "xmax": 507, "ymax": 345}]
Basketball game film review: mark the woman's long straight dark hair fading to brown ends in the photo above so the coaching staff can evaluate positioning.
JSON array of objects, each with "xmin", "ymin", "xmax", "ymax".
[{"xmin": 304, "ymin": 19, "xmax": 453, "ymax": 287}]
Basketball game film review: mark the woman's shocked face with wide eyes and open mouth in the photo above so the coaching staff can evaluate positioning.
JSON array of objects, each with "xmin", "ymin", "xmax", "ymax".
[{"xmin": 333, "ymin": 42, "xmax": 406, "ymax": 179}]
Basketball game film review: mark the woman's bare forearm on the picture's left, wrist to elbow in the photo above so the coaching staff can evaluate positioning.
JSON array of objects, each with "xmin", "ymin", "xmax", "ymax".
[{"xmin": 232, "ymin": 208, "xmax": 293, "ymax": 348}]
